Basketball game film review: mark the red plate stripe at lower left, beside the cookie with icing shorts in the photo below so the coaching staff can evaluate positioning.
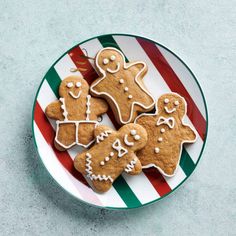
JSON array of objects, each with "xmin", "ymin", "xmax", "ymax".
[{"xmin": 34, "ymin": 102, "xmax": 89, "ymax": 186}]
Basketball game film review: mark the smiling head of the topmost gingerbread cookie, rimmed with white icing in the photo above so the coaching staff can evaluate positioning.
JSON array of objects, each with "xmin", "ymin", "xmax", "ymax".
[{"xmin": 96, "ymin": 47, "xmax": 124, "ymax": 74}]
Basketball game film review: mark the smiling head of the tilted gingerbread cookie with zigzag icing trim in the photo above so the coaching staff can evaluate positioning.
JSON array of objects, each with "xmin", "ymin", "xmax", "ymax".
[{"xmin": 119, "ymin": 123, "xmax": 147, "ymax": 151}]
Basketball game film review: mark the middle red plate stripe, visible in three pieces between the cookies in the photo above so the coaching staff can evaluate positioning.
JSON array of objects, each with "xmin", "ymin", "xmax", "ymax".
[{"xmin": 68, "ymin": 44, "xmax": 171, "ymax": 196}]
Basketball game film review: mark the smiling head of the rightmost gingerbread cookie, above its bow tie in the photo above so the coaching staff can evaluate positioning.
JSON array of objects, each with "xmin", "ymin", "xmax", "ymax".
[{"xmin": 157, "ymin": 93, "xmax": 186, "ymax": 117}]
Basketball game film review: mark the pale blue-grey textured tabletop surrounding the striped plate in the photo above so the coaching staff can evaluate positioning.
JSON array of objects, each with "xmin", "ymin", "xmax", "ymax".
[{"xmin": 0, "ymin": 0, "xmax": 236, "ymax": 235}]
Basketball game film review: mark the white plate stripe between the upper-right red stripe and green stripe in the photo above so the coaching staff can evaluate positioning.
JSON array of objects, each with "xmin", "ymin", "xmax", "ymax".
[{"xmin": 114, "ymin": 36, "xmax": 203, "ymax": 163}]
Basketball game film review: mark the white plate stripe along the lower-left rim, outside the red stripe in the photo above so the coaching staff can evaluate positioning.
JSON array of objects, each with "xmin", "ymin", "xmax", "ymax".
[{"xmin": 34, "ymin": 122, "xmax": 103, "ymax": 206}]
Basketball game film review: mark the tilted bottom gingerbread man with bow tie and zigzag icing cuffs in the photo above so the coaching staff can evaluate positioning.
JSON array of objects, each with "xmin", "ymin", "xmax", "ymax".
[{"xmin": 74, "ymin": 123, "xmax": 147, "ymax": 192}]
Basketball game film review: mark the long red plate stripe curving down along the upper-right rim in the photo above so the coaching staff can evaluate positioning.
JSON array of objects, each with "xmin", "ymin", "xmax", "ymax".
[{"xmin": 136, "ymin": 38, "xmax": 206, "ymax": 140}]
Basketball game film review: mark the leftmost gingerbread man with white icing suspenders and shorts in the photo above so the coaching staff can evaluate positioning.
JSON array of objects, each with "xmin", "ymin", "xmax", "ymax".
[{"xmin": 45, "ymin": 76, "xmax": 108, "ymax": 151}]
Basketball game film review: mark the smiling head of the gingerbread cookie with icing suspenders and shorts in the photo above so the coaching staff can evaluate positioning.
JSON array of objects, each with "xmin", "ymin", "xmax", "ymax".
[{"xmin": 59, "ymin": 76, "xmax": 89, "ymax": 100}]
